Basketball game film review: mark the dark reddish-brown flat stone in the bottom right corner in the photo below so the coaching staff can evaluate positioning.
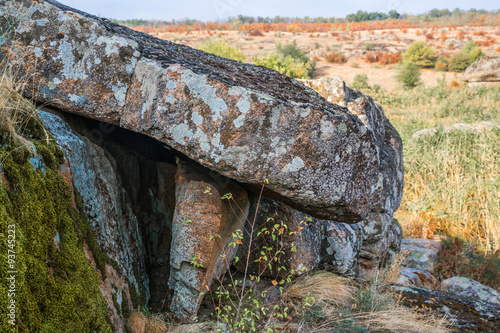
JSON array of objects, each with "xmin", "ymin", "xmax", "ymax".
[{"xmin": 392, "ymin": 286, "xmax": 500, "ymax": 332}]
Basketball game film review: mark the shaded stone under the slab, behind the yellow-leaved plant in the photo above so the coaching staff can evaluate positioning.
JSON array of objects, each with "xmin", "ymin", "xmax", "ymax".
[{"xmin": 237, "ymin": 195, "xmax": 321, "ymax": 279}]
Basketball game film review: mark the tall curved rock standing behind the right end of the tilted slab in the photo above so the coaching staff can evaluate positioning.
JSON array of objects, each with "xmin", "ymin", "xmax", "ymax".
[{"xmin": 301, "ymin": 77, "xmax": 403, "ymax": 273}]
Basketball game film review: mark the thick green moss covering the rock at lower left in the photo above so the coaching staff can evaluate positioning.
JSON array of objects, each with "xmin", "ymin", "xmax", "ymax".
[{"xmin": 0, "ymin": 108, "xmax": 112, "ymax": 332}]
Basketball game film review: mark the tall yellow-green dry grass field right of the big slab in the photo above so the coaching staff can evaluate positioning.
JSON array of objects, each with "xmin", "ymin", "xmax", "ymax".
[{"xmin": 369, "ymin": 86, "xmax": 500, "ymax": 253}]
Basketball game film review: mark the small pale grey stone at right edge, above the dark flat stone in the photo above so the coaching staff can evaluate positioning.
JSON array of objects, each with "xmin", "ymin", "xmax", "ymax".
[{"xmin": 441, "ymin": 276, "xmax": 500, "ymax": 305}]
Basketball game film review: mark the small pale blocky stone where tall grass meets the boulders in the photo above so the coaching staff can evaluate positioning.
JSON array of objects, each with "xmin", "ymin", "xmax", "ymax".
[{"xmin": 401, "ymin": 238, "xmax": 442, "ymax": 274}]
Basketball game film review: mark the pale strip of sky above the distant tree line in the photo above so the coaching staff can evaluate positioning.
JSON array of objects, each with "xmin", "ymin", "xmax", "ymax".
[{"xmin": 59, "ymin": 0, "xmax": 500, "ymax": 21}]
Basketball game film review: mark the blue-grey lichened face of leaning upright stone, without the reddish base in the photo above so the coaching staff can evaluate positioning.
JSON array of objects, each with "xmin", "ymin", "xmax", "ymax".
[{"xmin": 38, "ymin": 111, "xmax": 149, "ymax": 298}]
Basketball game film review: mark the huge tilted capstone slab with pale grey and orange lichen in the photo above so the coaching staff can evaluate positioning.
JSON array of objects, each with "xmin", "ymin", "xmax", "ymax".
[{"xmin": 0, "ymin": 0, "xmax": 382, "ymax": 222}]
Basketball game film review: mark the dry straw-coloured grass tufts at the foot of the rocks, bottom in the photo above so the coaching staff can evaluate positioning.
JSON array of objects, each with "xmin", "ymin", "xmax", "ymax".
[{"xmin": 280, "ymin": 268, "xmax": 450, "ymax": 333}]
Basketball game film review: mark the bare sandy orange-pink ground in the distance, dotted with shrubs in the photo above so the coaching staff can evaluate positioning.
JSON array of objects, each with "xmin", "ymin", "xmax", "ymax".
[{"xmin": 149, "ymin": 26, "xmax": 500, "ymax": 90}]
